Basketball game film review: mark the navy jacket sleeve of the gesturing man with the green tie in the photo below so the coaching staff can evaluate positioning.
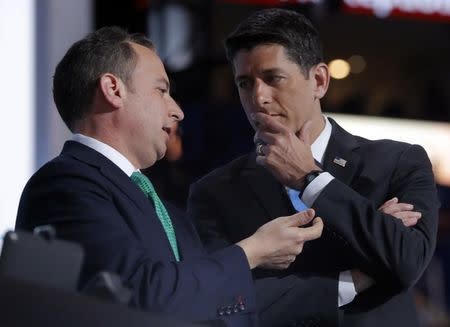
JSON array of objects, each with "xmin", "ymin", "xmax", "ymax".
[{"xmin": 16, "ymin": 174, "xmax": 256, "ymax": 326}]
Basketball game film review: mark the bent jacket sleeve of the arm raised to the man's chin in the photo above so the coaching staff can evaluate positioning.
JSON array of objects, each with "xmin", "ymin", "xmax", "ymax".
[{"xmin": 313, "ymin": 145, "xmax": 439, "ymax": 289}]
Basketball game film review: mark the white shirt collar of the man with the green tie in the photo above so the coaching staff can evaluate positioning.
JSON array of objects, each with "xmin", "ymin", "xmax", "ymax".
[{"xmin": 72, "ymin": 133, "xmax": 137, "ymax": 176}]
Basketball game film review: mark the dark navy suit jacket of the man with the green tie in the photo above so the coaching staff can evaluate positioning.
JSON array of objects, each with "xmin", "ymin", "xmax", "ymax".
[{"xmin": 16, "ymin": 141, "xmax": 256, "ymax": 326}]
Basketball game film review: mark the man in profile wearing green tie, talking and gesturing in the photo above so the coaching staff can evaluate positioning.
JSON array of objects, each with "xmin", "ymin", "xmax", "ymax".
[{"xmin": 16, "ymin": 27, "xmax": 326, "ymax": 326}]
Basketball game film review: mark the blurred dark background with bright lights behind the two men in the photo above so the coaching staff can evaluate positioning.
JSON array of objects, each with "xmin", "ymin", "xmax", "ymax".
[{"xmin": 0, "ymin": 0, "xmax": 450, "ymax": 326}]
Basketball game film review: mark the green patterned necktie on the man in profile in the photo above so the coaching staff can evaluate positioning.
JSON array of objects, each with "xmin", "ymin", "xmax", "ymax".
[{"xmin": 131, "ymin": 171, "xmax": 180, "ymax": 261}]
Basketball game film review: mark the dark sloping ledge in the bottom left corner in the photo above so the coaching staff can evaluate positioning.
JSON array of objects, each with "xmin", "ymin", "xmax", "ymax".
[{"xmin": 0, "ymin": 277, "xmax": 208, "ymax": 327}]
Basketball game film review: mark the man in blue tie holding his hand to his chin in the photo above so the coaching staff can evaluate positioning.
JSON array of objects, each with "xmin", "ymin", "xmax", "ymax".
[{"xmin": 188, "ymin": 9, "xmax": 439, "ymax": 327}]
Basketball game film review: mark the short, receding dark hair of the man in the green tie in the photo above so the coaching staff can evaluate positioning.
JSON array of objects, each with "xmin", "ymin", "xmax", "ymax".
[{"xmin": 53, "ymin": 27, "xmax": 154, "ymax": 132}]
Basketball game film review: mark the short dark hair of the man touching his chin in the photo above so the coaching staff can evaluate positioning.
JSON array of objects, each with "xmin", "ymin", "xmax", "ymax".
[{"xmin": 225, "ymin": 8, "xmax": 323, "ymax": 77}]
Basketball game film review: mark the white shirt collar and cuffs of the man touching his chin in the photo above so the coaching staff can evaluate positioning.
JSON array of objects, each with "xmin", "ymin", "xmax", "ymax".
[{"xmin": 286, "ymin": 116, "xmax": 356, "ymax": 306}]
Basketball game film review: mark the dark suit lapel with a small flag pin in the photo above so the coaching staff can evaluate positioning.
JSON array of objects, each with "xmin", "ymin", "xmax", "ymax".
[{"xmin": 323, "ymin": 118, "xmax": 360, "ymax": 185}]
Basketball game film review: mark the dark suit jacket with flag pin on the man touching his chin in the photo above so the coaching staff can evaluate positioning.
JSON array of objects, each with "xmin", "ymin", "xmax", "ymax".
[{"xmin": 188, "ymin": 119, "xmax": 439, "ymax": 327}]
